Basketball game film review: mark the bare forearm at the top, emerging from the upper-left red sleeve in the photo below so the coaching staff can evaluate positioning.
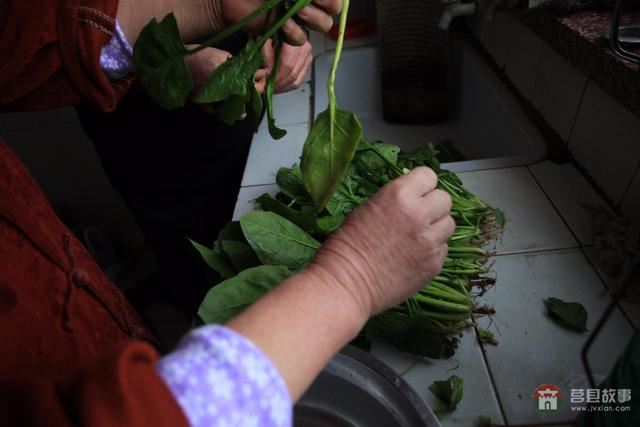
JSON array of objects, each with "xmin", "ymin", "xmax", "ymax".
[{"xmin": 116, "ymin": 0, "xmax": 224, "ymax": 45}]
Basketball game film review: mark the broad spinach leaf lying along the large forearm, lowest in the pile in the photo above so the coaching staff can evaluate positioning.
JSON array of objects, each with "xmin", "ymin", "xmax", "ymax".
[{"xmin": 198, "ymin": 265, "xmax": 293, "ymax": 324}]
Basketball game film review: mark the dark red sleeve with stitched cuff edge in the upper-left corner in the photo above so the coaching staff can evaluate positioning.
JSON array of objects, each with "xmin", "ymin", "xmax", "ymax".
[{"xmin": 0, "ymin": 0, "xmax": 134, "ymax": 112}]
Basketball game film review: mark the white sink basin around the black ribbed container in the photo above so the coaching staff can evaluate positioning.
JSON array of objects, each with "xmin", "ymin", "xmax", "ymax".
[{"xmin": 313, "ymin": 39, "xmax": 546, "ymax": 172}]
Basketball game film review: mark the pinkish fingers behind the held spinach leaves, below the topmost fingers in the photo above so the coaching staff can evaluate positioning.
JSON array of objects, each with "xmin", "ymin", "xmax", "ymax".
[{"xmin": 262, "ymin": 40, "xmax": 313, "ymax": 93}]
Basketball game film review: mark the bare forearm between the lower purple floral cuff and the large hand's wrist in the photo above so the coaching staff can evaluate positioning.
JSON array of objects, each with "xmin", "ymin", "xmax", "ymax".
[{"xmin": 227, "ymin": 267, "xmax": 368, "ymax": 401}]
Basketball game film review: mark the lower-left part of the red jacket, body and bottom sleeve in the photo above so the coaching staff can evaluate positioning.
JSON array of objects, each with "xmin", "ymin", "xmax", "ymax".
[{"xmin": 0, "ymin": 140, "xmax": 188, "ymax": 427}]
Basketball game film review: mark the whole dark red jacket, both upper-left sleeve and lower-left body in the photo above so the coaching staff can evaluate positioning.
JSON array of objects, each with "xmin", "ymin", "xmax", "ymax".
[{"xmin": 0, "ymin": 0, "xmax": 188, "ymax": 427}]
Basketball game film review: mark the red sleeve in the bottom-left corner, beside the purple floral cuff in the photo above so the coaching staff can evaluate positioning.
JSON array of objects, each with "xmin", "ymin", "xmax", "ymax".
[{"xmin": 0, "ymin": 341, "xmax": 189, "ymax": 427}]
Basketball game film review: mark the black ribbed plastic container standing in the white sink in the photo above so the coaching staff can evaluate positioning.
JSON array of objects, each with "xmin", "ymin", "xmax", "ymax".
[{"xmin": 376, "ymin": 0, "xmax": 451, "ymax": 124}]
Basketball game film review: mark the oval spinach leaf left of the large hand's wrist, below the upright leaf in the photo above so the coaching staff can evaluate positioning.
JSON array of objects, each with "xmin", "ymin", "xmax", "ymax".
[{"xmin": 240, "ymin": 212, "xmax": 320, "ymax": 270}]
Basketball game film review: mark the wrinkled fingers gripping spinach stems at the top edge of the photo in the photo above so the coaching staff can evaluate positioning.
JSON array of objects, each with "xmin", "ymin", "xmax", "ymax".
[{"xmin": 218, "ymin": 0, "xmax": 342, "ymax": 46}]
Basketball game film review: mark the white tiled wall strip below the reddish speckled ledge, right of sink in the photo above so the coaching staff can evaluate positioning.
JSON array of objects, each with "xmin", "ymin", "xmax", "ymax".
[{"xmin": 468, "ymin": 11, "xmax": 640, "ymax": 217}]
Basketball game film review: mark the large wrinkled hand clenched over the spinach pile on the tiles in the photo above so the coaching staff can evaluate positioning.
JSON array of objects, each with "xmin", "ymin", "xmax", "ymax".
[{"xmin": 310, "ymin": 167, "xmax": 455, "ymax": 319}]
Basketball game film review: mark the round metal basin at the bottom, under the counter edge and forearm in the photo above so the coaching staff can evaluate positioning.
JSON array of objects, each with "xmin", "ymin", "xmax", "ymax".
[{"xmin": 294, "ymin": 347, "xmax": 440, "ymax": 427}]
